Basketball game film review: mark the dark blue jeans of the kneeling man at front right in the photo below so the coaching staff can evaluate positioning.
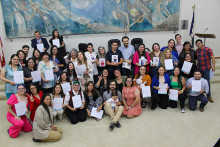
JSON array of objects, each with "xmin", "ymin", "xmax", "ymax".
[{"xmin": 189, "ymin": 94, "xmax": 208, "ymax": 111}]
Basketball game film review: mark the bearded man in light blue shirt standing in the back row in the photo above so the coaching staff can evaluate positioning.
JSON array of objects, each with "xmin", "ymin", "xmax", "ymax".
[{"xmin": 118, "ymin": 36, "xmax": 135, "ymax": 76}]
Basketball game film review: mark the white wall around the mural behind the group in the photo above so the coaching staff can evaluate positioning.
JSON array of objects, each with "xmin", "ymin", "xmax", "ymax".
[{"xmin": 0, "ymin": 0, "xmax": 220, "ymax": 63}]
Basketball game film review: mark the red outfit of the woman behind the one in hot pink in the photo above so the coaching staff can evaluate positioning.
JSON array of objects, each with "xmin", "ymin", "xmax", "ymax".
[{"xmin": 28, "ymin": 91, "xmax": 43, "ymax": 122}]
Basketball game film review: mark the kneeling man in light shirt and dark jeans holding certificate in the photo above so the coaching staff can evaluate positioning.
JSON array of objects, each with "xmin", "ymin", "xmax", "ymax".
[{"xmin": 186, "ymin": 71, "xmax": 209, "ymax": 112}]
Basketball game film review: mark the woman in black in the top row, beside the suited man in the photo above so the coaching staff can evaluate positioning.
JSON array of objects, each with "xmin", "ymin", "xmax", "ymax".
[{"xmin": 49, "ymin": 30, "xmax": 66, "ymax": 58}]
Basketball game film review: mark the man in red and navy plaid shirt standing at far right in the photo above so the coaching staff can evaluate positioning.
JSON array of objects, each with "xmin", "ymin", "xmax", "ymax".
[{"xmin": 196, "ymin": 39, "xmax": 215, "ymax": 103}]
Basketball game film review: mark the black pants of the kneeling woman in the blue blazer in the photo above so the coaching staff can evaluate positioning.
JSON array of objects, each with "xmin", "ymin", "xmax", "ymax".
[{"xmin": 151, "ymin": 92, "xmax": 169, "ymax": 109}]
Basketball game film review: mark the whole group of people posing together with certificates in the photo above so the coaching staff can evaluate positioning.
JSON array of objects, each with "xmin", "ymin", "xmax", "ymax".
[{"xmin": 1, "ymin": 30, "xmax": 215, "ymax": 142}]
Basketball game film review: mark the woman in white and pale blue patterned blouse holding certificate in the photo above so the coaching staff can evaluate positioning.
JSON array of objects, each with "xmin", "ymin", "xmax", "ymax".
[{"xmin": 38, "ymin": 52, "xmax": 59, "ymax": 93}]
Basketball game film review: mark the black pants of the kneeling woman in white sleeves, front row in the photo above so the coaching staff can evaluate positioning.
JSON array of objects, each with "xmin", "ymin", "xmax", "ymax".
[{"xmin": 66, "ymin": 108, "xmax": 87, "ymax": 124}]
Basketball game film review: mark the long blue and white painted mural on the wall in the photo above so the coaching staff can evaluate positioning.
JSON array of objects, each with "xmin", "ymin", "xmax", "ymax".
[{"xmin": 1, "ymin": 0, "xmax": 180, "ymax": 38}]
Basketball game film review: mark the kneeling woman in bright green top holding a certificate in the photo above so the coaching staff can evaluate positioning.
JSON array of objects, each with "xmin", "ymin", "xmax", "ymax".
[{"xmin": 169, "ymin": 67, "xmax": 186, "ymax": 113}]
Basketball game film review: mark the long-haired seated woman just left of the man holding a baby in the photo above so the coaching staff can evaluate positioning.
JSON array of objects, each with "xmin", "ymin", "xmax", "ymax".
[{"xmin": 84, "ymin": 81, "xmax": 103, "ymax": 121}]
